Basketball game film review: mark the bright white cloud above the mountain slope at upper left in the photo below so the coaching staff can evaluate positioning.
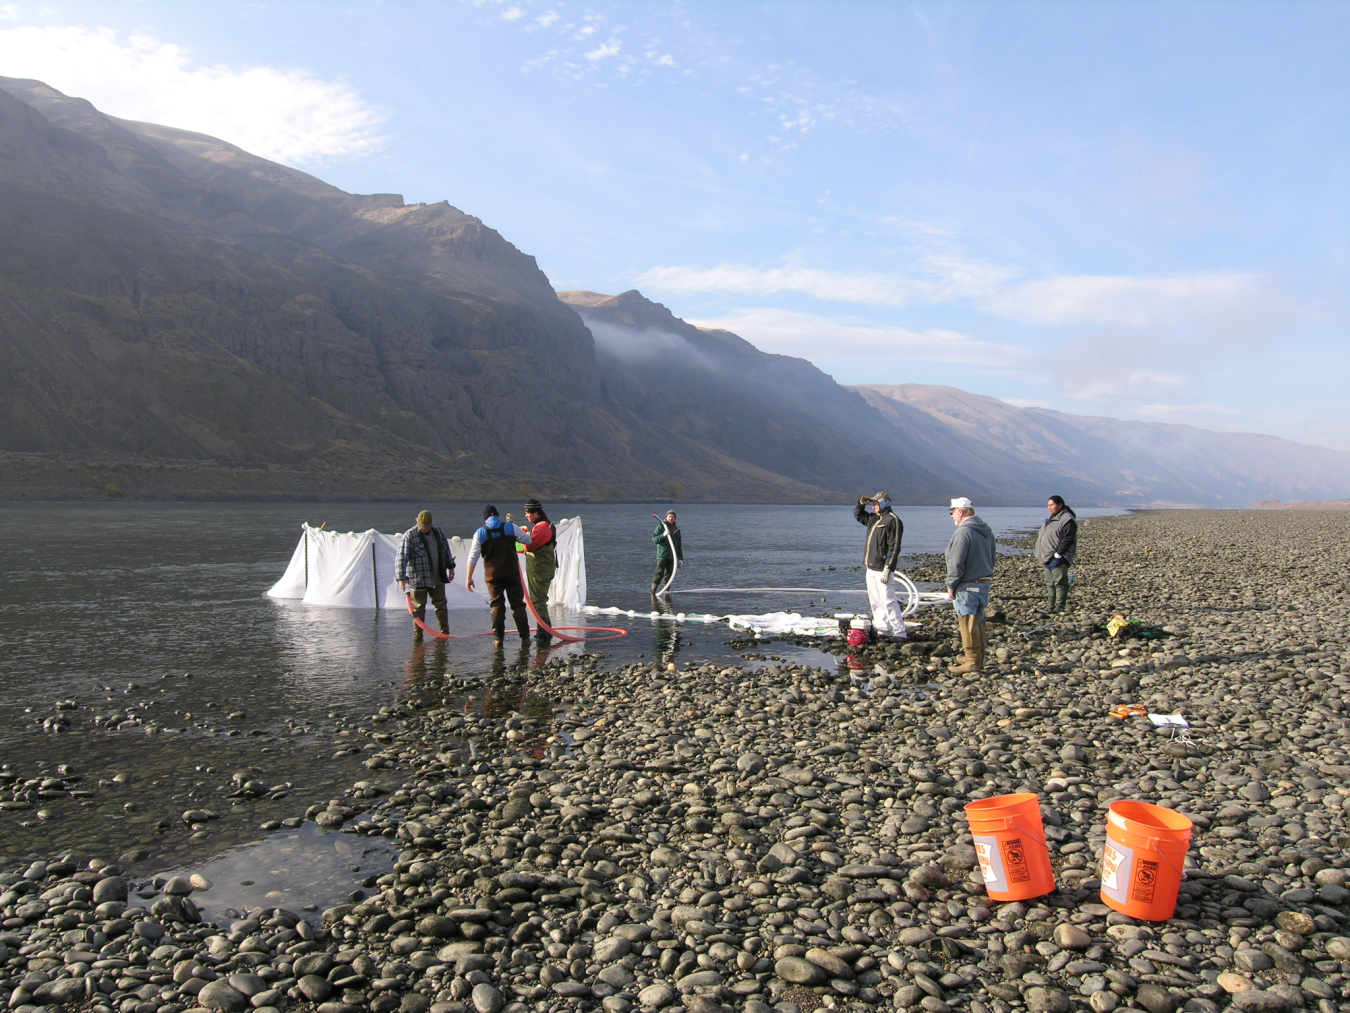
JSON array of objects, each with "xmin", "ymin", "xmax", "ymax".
[{"xmin": 0, "ymin": 26, "xmax": 383, "ymax": 165}]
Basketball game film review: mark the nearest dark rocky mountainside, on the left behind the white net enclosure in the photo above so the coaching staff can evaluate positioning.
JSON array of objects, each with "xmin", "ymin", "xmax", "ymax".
[{"xmin": 0, "ymin": 78, "xmax": 864, "ymax": 500}]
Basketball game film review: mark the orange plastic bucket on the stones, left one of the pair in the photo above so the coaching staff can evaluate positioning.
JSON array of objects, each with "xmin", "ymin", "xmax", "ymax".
[{"xmin": 965, "ymin": 791, "xmax": 1054, "ymax": 901}]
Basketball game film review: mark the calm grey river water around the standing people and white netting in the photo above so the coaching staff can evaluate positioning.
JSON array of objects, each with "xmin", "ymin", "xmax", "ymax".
[{"xmin": 0, "ymin": 502, "xmax": 1110, "ymax": 913}]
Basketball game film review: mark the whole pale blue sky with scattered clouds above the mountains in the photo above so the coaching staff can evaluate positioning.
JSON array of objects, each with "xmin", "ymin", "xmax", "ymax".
[{"xmin": 0, "ymin": 0, "xmax": 1350, "ymax": 450}]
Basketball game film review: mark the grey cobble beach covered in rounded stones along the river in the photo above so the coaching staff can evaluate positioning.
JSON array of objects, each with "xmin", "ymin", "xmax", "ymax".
[{"xmin": 0, "ymin": 511, "xmax": 1350, "ymax": 1013}]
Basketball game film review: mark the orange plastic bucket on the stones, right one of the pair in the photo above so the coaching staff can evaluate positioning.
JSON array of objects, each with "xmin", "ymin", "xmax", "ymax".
[{"xmin": 1102, "ymin": 802, "xmax": 1192, "ymax": 921}]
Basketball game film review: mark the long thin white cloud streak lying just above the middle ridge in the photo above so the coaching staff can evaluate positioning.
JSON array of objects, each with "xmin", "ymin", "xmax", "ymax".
[{"xmin": 690, "ymin": 308, "xmax": 1040, "ymax": 370}]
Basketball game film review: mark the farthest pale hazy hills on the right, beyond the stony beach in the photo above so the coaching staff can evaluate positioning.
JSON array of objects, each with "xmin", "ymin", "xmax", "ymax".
[{"xmin": 851, "ymin": 384, "xmax": 1350, "ymax": 507}]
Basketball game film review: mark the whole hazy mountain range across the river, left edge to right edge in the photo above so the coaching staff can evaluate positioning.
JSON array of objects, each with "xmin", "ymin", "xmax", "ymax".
[{"xmin": 0, "ymin": 78, "xmax": 1350, "ymax": 505}]
